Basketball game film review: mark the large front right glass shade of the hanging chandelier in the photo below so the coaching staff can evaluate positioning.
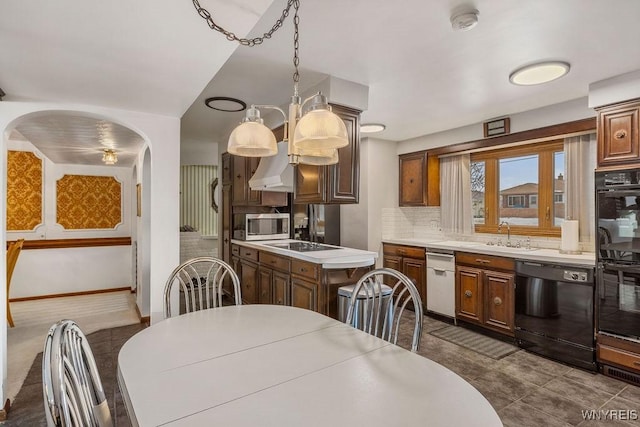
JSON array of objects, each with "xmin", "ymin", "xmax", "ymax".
[{"xmin": 293, "ymin": 108, "xmax": 349, "ymax": 150}]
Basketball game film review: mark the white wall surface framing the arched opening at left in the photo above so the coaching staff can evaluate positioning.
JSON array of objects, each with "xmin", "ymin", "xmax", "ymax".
[{"xmin": 0, "ymin": 101, "xmax": 180, "ymax": 402}]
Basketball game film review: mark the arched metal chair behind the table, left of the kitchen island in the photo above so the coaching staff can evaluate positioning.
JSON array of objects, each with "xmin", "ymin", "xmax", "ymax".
[{"xmin": 164, "ymin": 257, "xmax": 242, "ymax": 319}]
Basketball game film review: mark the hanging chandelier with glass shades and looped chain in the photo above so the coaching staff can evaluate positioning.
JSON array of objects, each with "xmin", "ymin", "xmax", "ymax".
[{"xmin": 193, "ymin": 0, "xmax": 349, "ymax": 165}]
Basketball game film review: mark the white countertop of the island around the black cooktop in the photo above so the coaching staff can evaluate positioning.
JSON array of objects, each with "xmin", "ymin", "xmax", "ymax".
[{"xmin": 231, "ymin": 239, "xmax": 378, "ymax": 269}]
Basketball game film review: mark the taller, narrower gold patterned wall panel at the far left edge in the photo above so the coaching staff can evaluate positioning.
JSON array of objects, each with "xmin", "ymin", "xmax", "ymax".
[{"xmin": 7, "ymin": 151, "xmax": 42, "ymax": 231}]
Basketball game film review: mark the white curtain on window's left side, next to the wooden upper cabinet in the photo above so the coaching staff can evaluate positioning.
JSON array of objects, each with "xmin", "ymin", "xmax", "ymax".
[{"xmin": 440, "ymin": 154, "xmax": 473, "ymax": 234}]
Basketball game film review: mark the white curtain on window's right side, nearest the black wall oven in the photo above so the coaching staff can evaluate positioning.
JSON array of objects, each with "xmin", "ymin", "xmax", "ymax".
[{"xmin": 564, "ymin": 133, "xmax": 596, "ymax": 244}]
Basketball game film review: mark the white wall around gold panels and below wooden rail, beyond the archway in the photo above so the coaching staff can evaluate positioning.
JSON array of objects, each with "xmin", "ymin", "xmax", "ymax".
[{"xmin": 7, "ymin": 140, "xmax": 135, "ymax": 298}]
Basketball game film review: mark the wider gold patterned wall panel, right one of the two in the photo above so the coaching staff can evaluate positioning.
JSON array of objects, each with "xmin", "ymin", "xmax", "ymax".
[{"xmin": 56, "ymin": 175, "xmax": 122, "ymax": 230}]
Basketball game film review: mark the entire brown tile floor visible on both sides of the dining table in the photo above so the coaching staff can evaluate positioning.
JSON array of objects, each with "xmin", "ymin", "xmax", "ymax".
[{"xmin": 6, "ymin": 317, "xmax": 640, "ymax": 427}]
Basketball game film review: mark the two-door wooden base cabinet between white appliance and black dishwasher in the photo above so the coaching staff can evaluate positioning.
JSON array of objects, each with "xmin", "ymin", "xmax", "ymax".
[{"xmin": 456, "ymin": 252, "xmax": 515, "ymax": 336}]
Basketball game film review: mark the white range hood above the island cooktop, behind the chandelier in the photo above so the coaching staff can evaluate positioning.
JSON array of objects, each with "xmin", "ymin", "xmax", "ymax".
[{"xmin": 249, "ymin": 141, "xmax": 294, "ymax": 193}]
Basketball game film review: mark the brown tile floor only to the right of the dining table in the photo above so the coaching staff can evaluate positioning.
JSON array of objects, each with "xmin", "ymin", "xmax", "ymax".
[{"xmin": 408, "ymin": 317, "xmax": 640, "ymax": 427}]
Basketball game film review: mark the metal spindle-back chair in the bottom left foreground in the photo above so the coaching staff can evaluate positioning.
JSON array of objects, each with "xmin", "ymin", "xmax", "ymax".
[{"xmin": 42, "ymin": 320, "xmax": 113, "ymax": 427}]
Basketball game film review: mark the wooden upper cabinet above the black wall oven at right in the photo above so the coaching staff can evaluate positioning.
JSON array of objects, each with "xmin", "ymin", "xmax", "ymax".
[{"xmin": 597, "ymin": 100, "xmax": 640, "ymax": 167}]
